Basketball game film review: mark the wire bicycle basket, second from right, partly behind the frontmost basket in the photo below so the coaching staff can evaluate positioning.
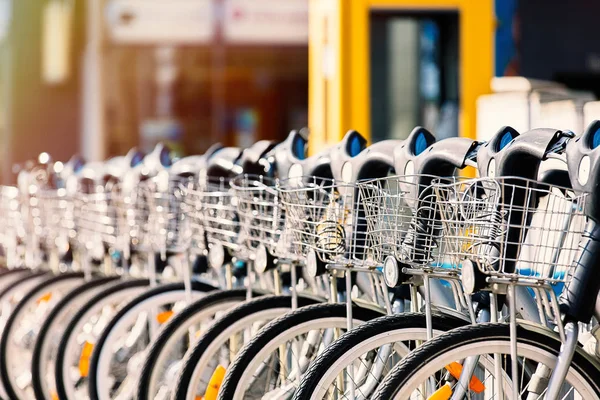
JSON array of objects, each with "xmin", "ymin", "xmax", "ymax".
[{"xmin": 358, "ymin": 176, "xmax": 447, "ymax": 268}]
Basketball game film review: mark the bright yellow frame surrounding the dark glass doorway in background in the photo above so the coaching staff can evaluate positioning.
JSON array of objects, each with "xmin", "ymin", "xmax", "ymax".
[{"xmin": 309, "ymin": 0, "xmax": 494, "ymax": 151}]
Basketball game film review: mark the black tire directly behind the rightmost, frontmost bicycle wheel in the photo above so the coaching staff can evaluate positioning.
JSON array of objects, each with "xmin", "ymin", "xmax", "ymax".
[{"xmin": 293, "ymin": 313, "xmax": 468, "ymax": 400}]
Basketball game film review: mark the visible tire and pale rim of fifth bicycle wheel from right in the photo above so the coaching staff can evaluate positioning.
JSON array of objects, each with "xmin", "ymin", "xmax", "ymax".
[{"xmin": 135, "ymin": 289, "xmax": 265, "ymax": 400}]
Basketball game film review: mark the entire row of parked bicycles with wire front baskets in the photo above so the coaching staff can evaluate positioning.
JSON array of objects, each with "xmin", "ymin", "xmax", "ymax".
[{"xmin": 0, "ymin": 121, "xmax": 600, "ymax": 400}]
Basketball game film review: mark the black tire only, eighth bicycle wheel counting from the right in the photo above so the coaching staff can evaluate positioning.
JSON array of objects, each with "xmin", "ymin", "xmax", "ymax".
[{"xmin": 31, "ymin": 276, "xmax": 119, "ymax": 400}]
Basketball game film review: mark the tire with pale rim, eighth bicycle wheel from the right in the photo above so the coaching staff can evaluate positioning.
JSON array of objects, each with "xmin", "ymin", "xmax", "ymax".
[{"xmin": 31, "ymin": 276, "xmax": 119, "ymax": 400}]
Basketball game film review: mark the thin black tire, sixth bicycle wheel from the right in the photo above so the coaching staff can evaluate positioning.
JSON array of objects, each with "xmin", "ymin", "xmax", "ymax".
[{"xmin": 88, "ymin": 281, "xmax": 216, "ymax": 400}]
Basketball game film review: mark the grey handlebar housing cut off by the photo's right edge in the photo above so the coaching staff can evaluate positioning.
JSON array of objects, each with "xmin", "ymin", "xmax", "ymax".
[{"xmin": 566, "ymin": 120, "xmax": 600, "ymax": 222}]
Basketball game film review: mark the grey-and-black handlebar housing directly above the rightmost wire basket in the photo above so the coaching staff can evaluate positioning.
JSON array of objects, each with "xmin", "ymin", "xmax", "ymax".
[{"xmin": 477, "ymin": 127, "xmax": 572, "ymax": 179}]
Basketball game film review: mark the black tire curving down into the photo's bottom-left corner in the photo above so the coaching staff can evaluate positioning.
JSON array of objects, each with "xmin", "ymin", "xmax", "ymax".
[{"xmin": 0, "ymin": 272, "xmax": 83, "ymax": 400}]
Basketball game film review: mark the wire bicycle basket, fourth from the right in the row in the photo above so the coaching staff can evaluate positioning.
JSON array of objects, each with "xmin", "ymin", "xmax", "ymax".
[{"xmin": 231, "ymin": 174, "xmax": 287, "ymax": 257}]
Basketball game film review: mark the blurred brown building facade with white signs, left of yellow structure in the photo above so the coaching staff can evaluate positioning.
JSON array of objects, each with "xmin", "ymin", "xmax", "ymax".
[{"xmin": 0, "ymin": 0, "xmax": 308, "ymax": 180}]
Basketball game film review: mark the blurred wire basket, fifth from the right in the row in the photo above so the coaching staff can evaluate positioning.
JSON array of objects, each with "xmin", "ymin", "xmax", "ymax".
[{"xmin": 184, "ymin": 177, "xmax": 241, "ymax": 255}]
